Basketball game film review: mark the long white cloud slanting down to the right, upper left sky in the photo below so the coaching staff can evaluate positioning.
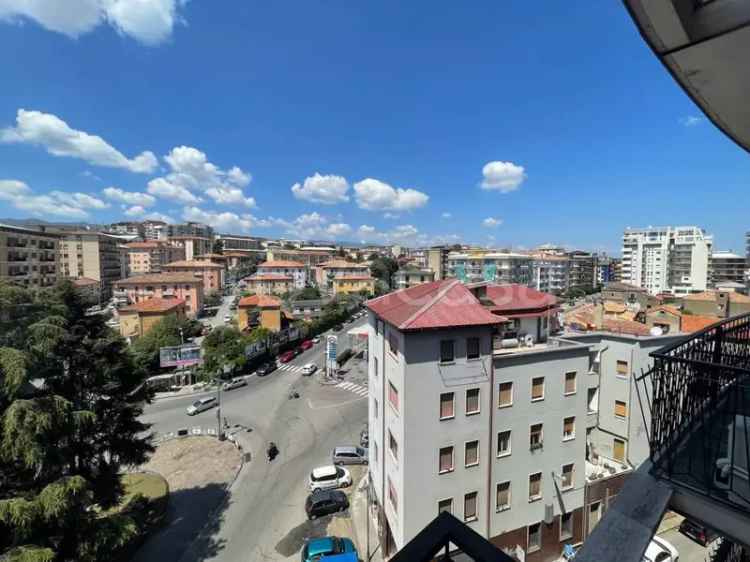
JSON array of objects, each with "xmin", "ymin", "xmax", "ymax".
[{"xmin": 0, "ymin": 108, "xmax": 157, "ymax": 173}]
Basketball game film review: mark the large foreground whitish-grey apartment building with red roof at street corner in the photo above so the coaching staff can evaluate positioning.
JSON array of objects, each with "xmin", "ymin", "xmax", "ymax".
[{"xmin": 368, "ymin": 280, "xmax": 680, "ymax": 562}]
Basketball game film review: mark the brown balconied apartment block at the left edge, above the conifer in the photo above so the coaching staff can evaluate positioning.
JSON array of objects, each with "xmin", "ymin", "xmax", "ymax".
[{"xmin": 0, "ymin": 224, "xmax": 60, "ymax": 287}]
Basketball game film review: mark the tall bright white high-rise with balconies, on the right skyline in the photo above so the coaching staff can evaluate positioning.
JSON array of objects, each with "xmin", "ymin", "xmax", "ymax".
[{"xmin": 622, "ymin": 226, "xmax": 713, "ymax": 295}]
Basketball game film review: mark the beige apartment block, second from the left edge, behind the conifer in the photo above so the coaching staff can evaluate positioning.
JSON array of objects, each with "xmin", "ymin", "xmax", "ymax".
[{"xmin": 60, "ymin": 230, "xmax": 122, "ymax": 300}]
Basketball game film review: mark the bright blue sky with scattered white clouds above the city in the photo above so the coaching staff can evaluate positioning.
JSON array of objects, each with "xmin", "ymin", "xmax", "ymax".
[{"xmin": 0, "ymin": 0, "xmax": 750, "ymax": 252}]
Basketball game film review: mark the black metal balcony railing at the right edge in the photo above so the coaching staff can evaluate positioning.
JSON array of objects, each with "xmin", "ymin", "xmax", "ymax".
[{"xmin": 639, "ymin": 314, "xmax": 750, "ymax": 510}]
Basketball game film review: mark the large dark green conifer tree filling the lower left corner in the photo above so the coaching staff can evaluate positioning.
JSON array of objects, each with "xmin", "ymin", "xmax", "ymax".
[{"xmin": 0, "ymin": 282, "xmax": 153, "ymax": 562}]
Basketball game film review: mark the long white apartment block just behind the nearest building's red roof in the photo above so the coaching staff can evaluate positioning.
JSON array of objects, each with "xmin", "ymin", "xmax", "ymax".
[{"xmin": 448, "ymin": 250, "xmax": 533, "ymax": 286}]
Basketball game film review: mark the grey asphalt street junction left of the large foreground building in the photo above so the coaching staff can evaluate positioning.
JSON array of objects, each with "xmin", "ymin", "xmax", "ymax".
[{"xmin": 139, "ymin": 308, "xmax": 367, "ymax": 562}]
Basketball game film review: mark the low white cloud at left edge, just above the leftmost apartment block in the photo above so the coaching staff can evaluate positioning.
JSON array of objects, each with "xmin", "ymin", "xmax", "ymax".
[{"xmin": 0, "ymin": 180, "xmax": 107, "ymax": 219}]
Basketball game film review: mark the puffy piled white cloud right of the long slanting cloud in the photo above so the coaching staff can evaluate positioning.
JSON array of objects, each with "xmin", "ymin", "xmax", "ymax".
[{"xmin": 148, "ymin": 146, "xmax": 256, "ymax": 209}]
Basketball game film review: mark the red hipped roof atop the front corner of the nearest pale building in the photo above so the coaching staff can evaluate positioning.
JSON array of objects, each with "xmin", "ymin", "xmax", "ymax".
[{"xmin": 367, "ymin": 279, "xmax": 503, "ymax": 331}]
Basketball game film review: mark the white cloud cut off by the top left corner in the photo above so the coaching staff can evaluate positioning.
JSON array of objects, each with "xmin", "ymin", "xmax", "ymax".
[{"xmin": 0, "ymin": 0, "xmax": 187, "ymax": 45}]
